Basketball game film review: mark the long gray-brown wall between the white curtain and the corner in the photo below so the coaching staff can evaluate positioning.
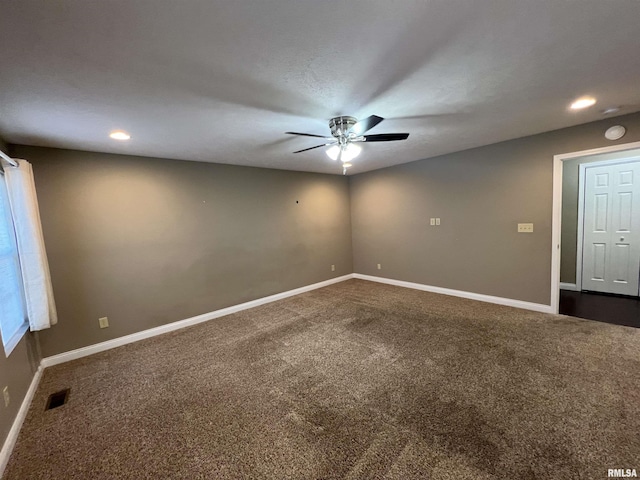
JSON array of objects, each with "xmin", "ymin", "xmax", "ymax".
[{"xmin": 12, "ymin": 146, "xmax": 353, "ymax": 357}]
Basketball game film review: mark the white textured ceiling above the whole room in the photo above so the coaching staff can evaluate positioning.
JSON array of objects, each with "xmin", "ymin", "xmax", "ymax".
[{"xmin": 0, "ymin": 0, "xmax": 640, "ymax": 174}]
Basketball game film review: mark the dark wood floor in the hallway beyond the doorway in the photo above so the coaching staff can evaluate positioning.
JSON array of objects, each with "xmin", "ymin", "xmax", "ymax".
[{"xmin": 560, "ymin": 290, "xmax": 640, "ymax": 328}]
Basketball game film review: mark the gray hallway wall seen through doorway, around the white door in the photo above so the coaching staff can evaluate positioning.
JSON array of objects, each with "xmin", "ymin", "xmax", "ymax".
[{"xmin": 560, "ymin": 148, "xmax": 639, "ymax": 283}]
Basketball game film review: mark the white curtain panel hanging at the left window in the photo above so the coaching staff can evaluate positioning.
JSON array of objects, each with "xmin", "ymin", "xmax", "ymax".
[{"xmin": 4, "ymin": 160, "xmax": 58, "ymax": 331}]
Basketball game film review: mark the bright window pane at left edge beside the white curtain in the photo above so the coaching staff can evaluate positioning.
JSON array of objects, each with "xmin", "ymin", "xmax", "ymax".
[{"xmin": 0, "ymin": 175, "xmax": 29, "ymax": 356}]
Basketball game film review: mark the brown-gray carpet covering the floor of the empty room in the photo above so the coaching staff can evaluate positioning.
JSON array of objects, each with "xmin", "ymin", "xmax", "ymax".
[{"xmin": 5, "ymin": 280, "xmax": 640, "ymax": 480}]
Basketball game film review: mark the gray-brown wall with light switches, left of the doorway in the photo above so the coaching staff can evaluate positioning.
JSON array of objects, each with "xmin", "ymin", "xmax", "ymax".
[{"xmin": 350, "ymin": 114, "xmax": 640, "ymax": 305}]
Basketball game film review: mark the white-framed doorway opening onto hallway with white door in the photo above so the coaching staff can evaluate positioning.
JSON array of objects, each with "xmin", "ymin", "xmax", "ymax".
[{"xmin": 551, "ymin": 142, "xmax": 640, "ymax": 327}]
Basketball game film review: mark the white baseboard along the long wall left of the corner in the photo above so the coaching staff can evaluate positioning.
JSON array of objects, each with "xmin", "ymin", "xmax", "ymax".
[{"xmin": 41, "ymin": 274, "xmax": 353, "ymax": 367}]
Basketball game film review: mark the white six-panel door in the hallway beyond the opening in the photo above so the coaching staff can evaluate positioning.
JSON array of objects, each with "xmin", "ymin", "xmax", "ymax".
[{"xmin": 582, "ymin": 162, "xmax": 640, "ymax": 296}]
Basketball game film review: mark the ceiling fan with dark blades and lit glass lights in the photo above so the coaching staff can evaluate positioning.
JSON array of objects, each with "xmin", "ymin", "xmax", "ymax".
[{"xmin": 284, "ymin": 115, "xmax": 409, "ymax": 174}]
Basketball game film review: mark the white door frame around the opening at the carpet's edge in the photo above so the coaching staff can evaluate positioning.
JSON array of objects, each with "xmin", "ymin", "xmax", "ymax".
[{"xmin": 551, "ymin": 142, "xmax": 640, "ymax": 313}]
